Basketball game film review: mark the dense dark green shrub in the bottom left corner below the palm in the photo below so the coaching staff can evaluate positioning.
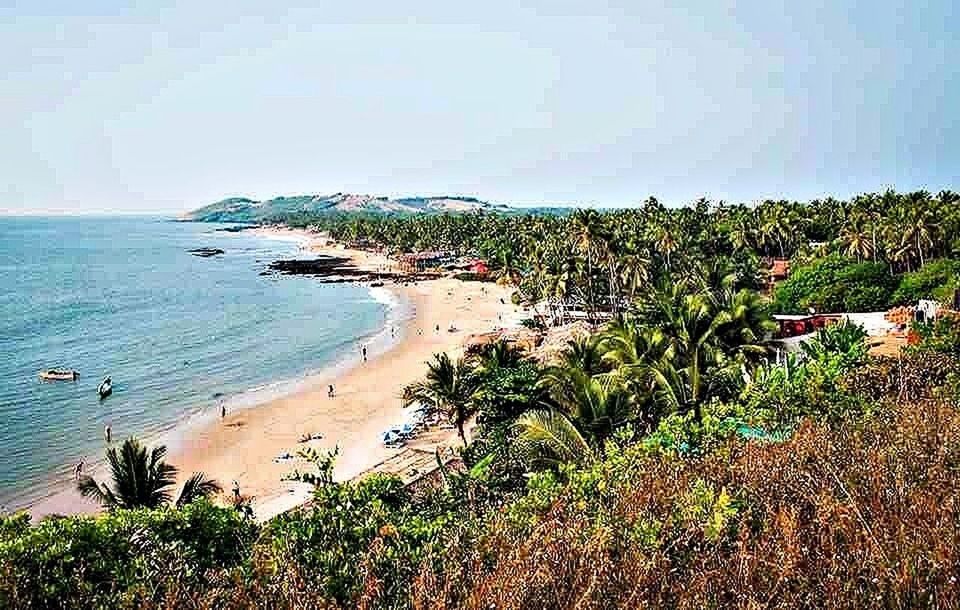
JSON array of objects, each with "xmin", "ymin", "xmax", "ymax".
[{"xmin": 0, "ymin": 500, "xmax": 257, "ymax": 608}]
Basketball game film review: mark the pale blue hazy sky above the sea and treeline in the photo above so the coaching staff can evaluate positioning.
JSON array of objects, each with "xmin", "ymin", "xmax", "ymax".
[{"xmin": 0, "ymin": 0, "xmax": 960, "ymax": 214}]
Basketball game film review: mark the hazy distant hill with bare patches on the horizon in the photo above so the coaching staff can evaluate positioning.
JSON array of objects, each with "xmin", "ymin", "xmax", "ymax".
[{"xmin": 182, "ymin": 193, "xmax": 516, "ymax": 222}]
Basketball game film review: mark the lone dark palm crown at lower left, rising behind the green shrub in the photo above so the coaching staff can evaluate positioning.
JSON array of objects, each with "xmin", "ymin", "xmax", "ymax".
[{"xmin": 77, "ymin": 438, "xmax": 220, "ymax": 510}]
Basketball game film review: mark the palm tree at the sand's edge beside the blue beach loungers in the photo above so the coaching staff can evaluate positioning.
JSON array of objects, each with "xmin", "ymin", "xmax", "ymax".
[{"xmin": 403, "ymin": 353, "xmax": 476, "ymax": 447}]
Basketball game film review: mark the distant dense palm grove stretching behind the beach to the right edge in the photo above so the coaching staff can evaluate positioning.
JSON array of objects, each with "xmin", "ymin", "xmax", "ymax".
[{"xmin": 284, "ymin": 191, "xmax": 960, "ymax": 309}]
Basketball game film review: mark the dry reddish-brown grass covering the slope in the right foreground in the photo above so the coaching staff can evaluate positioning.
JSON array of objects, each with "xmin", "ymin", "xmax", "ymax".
[{"xmin": 413, "ymin": 401, "xmax": 960, "ymax": 610}]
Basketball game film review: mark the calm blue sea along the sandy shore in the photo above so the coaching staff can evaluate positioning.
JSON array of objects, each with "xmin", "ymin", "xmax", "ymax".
[{"xmin": 0, "ymin": 217, "xmax": 389, "ymax": 508}]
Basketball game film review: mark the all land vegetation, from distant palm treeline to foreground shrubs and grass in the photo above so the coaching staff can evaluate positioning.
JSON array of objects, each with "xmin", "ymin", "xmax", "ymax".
[{"xmin": 0, "ymin": 192, "xmax": 960, "ymax": 609}]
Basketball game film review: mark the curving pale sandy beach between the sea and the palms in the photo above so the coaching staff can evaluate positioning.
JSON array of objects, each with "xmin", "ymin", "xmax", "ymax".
[{"xmin": 30, "ymin": 229, "xmax": 520, "ymax": 520}]
